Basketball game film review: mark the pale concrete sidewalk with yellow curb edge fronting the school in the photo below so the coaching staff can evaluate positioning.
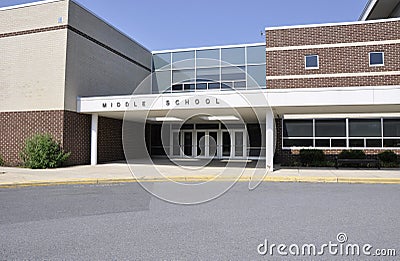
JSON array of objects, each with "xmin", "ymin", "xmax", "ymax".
[{"xmin": 0, "ymin": 162, "xmax": 400, "ymax": 188}]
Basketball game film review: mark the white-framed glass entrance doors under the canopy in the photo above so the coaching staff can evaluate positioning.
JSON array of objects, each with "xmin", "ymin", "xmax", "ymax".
[{"xmin": 172, "ymin": 130, "xmax": 247, "ymax": 158}]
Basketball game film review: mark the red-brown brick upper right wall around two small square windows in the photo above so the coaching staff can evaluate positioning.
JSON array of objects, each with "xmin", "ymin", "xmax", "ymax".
[{"xmin": 266, "ymin": 21, "xmax": 400, "ymax": 89}]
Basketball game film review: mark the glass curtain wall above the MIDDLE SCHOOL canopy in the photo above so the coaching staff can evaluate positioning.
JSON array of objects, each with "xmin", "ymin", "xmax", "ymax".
[{"xmin": 152, "ymin": 44, "xmax": 266, "ymax": 93}]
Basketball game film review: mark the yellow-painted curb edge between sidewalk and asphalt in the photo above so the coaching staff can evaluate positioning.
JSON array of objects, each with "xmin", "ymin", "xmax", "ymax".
[{"xmin": 0, "ymin": 176, "xmax": 400, "ymax": 188}]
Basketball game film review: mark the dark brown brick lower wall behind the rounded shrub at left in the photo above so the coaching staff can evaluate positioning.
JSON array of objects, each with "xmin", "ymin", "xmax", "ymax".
[{"xmin": 0, "ymin": 111, "xmax": 124, "ymax": 166}]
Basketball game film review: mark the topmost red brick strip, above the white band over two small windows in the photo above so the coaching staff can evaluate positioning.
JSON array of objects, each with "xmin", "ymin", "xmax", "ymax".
[{"xmin": 266, "ymin": 21, "xmax": 400, "ymax": 47}]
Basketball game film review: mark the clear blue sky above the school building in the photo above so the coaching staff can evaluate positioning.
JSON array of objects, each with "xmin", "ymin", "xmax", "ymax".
[{"xmin": 0, "ymin": 0, "xmax": 367, "ymax": 50}]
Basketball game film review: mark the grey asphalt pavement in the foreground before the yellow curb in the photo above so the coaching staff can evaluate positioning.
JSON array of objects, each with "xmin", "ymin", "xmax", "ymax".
[{"xmin": 0, "ymin": 182, "xmax": 400, "ymax": 260}]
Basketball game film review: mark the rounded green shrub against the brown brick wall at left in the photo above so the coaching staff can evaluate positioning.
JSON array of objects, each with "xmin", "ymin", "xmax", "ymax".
[{"xmin": 20, "ymin": 134, "xmax": 70, "ymax": 169}]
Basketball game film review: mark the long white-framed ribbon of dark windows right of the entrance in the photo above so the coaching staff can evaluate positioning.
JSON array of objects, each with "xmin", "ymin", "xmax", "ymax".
[{"xmin": 282, "ymin": 118, "xmax": 400, "ymax": 149}]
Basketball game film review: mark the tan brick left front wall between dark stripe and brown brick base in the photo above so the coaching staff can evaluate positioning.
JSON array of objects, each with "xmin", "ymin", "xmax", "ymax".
[{"xmin": 0, "ymin": 29, "xmax": 67, "ymax": 112}]
